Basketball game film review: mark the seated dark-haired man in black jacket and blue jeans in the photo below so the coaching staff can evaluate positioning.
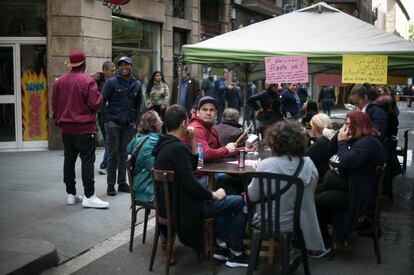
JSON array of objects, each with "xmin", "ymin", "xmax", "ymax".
[{"xmin": 153, "ymin": 104, "xmax": 248, "ymax": 267}]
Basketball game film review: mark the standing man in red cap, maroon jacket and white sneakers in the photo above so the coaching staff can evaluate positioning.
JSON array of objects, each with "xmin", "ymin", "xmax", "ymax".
[{"xmin": 52, "ymin": 51, "xmax": 109, "ymax": 208}]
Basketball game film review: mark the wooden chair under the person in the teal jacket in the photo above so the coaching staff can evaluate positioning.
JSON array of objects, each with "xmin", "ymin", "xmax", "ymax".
[{"xmin": 126, "ymin": 158, "xmax": 156, "ymax": 251}]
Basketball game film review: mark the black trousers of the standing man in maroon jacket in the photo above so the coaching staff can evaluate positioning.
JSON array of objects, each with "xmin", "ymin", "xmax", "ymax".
[{"xmin": 62, "ymin": 133, "xmax": 96, "ymax": 198}]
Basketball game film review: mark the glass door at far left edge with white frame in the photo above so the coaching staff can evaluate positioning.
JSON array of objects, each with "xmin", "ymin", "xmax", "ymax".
[{"xmin": 0, "ymin": 45, "xmax": 18, "ymax": 149}]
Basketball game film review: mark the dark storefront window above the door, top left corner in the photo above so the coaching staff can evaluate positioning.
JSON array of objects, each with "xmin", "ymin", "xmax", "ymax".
[{"xmin": 0, "ymin": 0, "xmax": 46, "ymax": 36}]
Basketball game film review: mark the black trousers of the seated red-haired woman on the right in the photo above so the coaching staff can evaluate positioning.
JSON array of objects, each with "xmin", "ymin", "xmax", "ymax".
[{"xmin": 315, "ymin": 170, "xmax": 348, "ymax": 246}]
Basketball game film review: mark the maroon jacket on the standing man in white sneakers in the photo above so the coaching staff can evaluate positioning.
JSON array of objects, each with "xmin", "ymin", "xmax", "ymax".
[{"xmin": 52, "ymin": 68, "xmax": 103, "ymax": 135}]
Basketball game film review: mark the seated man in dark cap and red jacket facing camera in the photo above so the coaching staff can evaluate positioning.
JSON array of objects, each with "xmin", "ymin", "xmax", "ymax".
[{"xmin": 183, "ymin": 96, "xmax": 251, "ymax": 194}]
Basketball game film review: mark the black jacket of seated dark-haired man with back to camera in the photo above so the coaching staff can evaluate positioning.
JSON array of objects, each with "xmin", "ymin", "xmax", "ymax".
[{"xmin": 153, "ymin": 135, "xmax": 212, "ymax": 251}]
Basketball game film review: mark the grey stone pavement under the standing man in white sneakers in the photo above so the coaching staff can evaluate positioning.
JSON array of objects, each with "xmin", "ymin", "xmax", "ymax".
[{"xmin": 0, "ymin": 150, "xmax": 141, "ymax": 274}]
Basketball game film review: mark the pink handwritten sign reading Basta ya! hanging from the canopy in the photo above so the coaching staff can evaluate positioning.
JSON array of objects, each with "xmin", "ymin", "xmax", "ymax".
[{"xmin": 265, "ymin": 56, "xmax": 308, "ymax": 84}]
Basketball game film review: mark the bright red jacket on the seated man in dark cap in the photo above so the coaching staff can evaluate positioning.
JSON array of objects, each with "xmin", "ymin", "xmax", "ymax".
[{"xmin": 183, "ymin": 115, "xmax": 237, "ymax": 162}]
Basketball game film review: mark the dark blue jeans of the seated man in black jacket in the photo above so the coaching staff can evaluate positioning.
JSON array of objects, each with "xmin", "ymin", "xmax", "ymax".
[{"xmin": 203, "ymin": 195, "xmax": 246, "ymax": 251}]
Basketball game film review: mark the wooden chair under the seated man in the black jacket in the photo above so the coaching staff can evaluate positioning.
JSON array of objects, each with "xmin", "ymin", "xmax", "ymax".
[{"xmin": 149, "ymin": 169, "xmax": 216, "ymax": 275}]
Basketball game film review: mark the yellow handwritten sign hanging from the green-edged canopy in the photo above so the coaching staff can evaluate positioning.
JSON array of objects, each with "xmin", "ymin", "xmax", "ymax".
[{"xmin": 342, "ymin": 55, "xmax": 388, "ymax": 84}]
